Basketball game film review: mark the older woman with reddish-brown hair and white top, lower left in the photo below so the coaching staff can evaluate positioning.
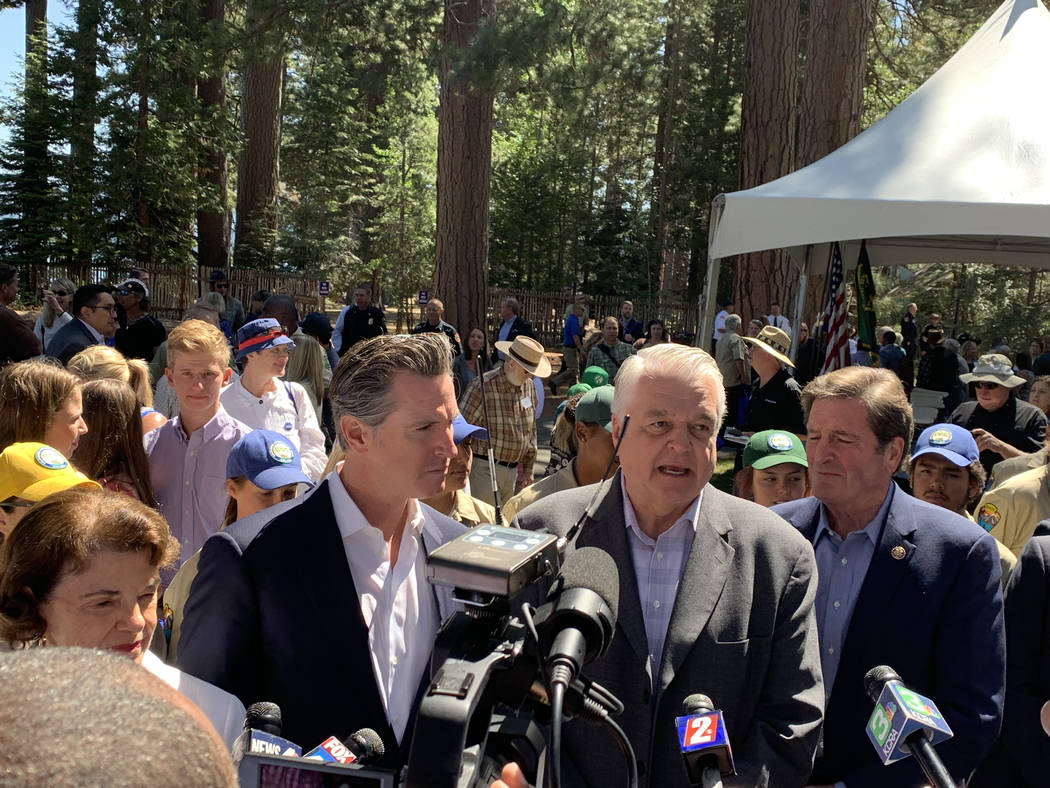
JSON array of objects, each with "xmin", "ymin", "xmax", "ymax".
[{"xmin": 0, "ymin": 489, "xmax": 245, "ymax": 746}]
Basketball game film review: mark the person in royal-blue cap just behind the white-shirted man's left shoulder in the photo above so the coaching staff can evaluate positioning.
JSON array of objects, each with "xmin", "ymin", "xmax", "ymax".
[{"xmin": 163, "ymin": 430, "xmax": 314, "ymax": 662}]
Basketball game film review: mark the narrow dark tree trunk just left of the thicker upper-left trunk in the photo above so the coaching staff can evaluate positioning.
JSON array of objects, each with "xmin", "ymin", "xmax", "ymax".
[{"xmin": 197, "ymin": 0, "xmax": 230, "ymax": 269}]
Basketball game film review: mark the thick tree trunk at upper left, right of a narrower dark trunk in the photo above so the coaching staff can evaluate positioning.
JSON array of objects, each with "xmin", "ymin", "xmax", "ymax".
[{"xmin": 233, "ymin": 0, "xmax": 286, "ymax": 269}]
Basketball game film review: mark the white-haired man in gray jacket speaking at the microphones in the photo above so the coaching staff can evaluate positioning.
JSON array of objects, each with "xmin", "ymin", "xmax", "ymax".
[{"xmin": 505, "ymin": 345, "xmax": 823, "ymax": 788}]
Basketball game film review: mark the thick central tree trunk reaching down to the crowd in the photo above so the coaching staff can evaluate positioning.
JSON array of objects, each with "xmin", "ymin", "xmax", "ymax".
[{"xmin": 434, "ymin": 0, "xmax": 495, "ymax": 336}]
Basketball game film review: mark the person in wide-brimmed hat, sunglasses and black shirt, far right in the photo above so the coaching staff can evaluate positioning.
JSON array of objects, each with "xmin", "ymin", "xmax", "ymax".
[{"xmin": 948, "ymin": 353, "xmax": 1047, "ymax": 479}]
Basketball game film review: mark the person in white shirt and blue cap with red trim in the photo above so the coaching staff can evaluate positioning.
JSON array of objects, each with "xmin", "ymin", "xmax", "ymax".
[{"xmin": 222, "ymin": 317, "xmax": 328, "ymax": 481}]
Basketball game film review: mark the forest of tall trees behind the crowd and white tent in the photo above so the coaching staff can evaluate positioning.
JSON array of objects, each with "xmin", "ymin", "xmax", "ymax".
[{"xmin": 0, "ymin": 0, "xmax": 1048, "ymax": 347}]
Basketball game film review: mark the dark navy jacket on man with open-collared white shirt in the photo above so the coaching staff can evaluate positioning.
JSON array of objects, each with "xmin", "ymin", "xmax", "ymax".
[{"xmin": 179, "ymin": 480, "xmax": 465, "ymax": 769}]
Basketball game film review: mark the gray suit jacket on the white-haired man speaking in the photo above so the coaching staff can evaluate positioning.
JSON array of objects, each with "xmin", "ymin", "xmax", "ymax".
[{"xmin": 518, "ymin": 474, "xmax": 824, "ymax": 788}]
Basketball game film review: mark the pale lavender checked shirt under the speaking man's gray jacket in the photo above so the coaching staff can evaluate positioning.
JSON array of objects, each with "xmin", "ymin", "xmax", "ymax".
[{"xmin": 624, "ymin": 488, "xmax": 704, "ymax": 677}]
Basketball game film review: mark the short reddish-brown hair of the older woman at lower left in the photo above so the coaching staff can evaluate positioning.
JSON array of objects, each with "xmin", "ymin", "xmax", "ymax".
[{"xmin": 0, "ymin": 488, "xmax": 179, "ymax": 644}]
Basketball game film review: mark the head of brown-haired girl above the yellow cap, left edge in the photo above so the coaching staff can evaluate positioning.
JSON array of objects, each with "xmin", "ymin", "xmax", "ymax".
[{"xmin": 0, "ymin": 359, "xmax": 87, "ymax": 459}]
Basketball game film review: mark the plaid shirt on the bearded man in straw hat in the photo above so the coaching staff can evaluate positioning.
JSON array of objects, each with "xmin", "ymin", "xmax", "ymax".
[{"xmin": 460, "ymin": 366, "xmax": 536, "ymax": 476}]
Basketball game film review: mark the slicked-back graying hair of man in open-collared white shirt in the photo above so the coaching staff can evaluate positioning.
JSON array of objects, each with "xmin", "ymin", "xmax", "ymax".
[{"xmin": 329, "ymin": 333, "xmax": 452, "ymax": 441}]
